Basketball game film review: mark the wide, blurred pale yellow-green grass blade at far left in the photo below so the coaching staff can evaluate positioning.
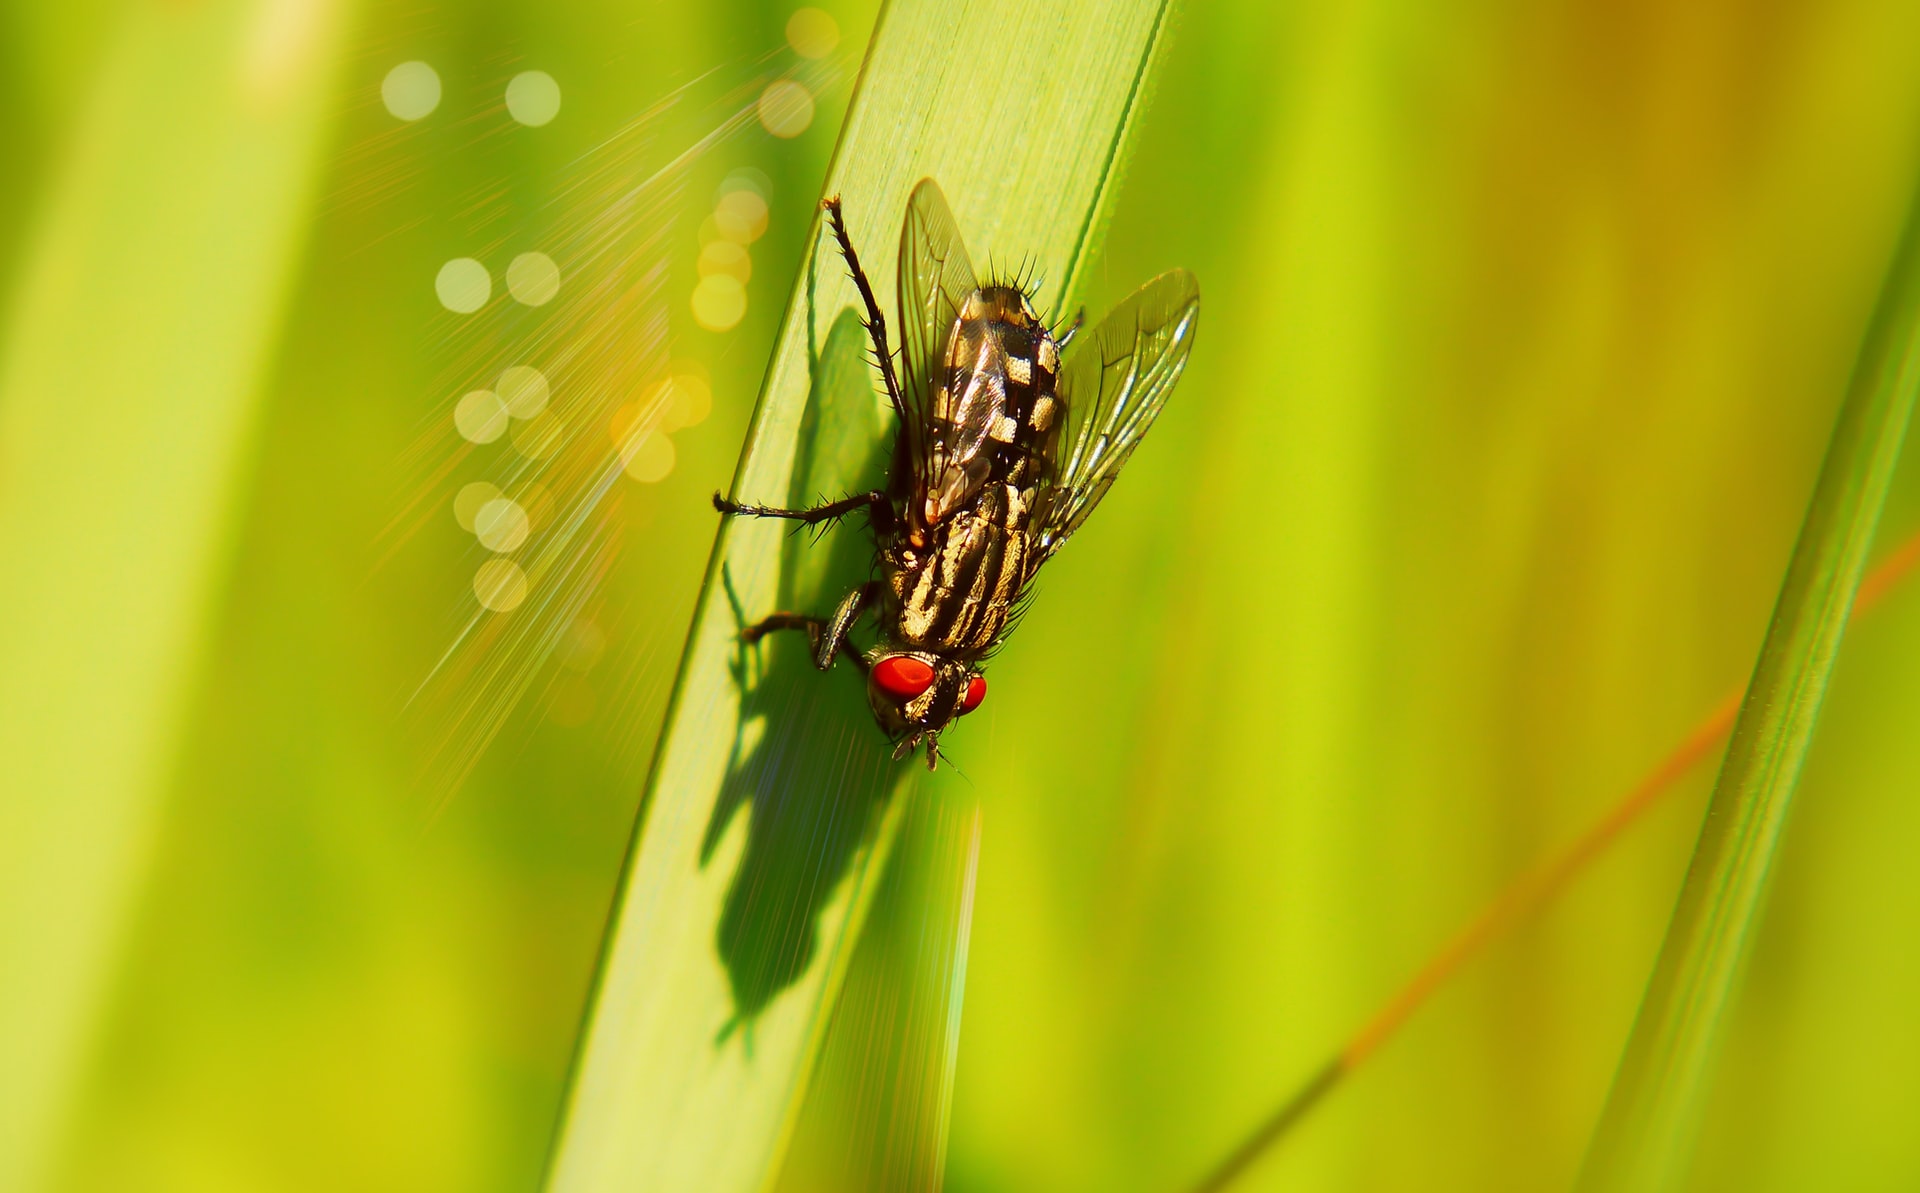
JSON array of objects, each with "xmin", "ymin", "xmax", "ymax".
[{"xmin": 0, "ymin": 0, "xmax": 346, "ymax": 1189}]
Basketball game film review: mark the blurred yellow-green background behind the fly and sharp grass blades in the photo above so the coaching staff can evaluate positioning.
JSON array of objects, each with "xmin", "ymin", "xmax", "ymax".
[{"xmin": 0, "ymin": 0, "xmax": 1920, "ymax": 1193}]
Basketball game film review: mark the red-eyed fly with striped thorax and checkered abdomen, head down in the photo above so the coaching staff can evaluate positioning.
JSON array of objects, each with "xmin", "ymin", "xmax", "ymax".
[{"xmin": 714, "ymin": 179, "xmax": 1200, "ymax": 770}]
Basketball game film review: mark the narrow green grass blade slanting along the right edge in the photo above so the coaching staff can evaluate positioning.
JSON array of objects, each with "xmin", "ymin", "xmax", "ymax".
[{"xmin": 1580, "ymin": 171, "xmax": 1920, "ymax": 1193}]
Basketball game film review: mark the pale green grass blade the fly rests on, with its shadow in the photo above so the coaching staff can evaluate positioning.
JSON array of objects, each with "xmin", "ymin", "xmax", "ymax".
[{"xmin": 549, "ymin": 0, "xmax": 1167, "ymax": 1193}]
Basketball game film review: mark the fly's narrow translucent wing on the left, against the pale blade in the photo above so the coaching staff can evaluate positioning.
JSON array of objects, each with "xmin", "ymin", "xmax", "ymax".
[{"xmin": 899, "ymin": 179, "xmax": 977, "ymax": 509}]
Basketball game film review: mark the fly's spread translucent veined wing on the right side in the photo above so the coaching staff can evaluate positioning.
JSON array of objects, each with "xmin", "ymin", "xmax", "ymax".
[{"xmin": 1035, "ymin": 269, "xmax": 1200, "ymax": 565}]
